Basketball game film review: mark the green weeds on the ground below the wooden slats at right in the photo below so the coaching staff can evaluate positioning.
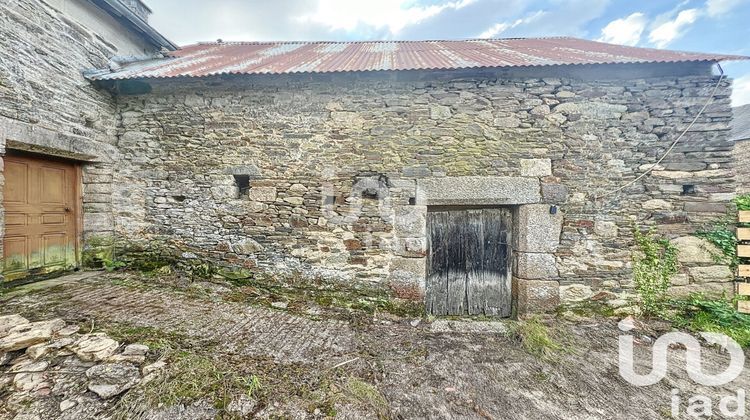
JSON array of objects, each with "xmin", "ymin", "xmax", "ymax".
[{"xmin": 669, "ymin": 294, "xmax": 750, "ymax": 348}]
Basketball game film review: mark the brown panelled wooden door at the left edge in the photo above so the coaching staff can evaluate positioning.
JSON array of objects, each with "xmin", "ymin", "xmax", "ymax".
[{"xmin": 3, "ymin": 155, "xmax": 78, "ymax": 281}]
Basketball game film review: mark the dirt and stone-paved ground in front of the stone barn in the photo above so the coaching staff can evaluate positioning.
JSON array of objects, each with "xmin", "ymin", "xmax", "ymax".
[{"xmin": 0, "ymin": 273, "xmax": 750, "ymax": 419}]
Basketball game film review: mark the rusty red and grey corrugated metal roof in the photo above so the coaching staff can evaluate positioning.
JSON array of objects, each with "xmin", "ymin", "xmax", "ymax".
[{"xmin": 89, "ymin": 38, "xmax": 748, "ymax": 80}]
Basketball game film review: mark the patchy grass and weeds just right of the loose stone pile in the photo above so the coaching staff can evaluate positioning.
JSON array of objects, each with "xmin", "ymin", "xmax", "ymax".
[{"xmin": 102, "ymin": 316, "xmax": 388, "ymax": 420}]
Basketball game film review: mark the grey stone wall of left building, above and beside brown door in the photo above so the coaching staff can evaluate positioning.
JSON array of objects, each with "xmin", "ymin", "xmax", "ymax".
[{"xmin": 0, "ymin": 0, "xmax": 160, "ymax": 276}]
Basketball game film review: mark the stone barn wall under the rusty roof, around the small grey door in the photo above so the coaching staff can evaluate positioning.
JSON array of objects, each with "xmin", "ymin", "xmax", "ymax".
[{"xmin": 113, "ymin": 65, "xmax": 734, "ymax": 308}]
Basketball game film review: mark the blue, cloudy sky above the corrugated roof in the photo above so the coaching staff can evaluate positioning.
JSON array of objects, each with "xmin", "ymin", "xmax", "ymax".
[{"xmin": 145, "ymin": 0, "xmax": 750, "ymax": 106}]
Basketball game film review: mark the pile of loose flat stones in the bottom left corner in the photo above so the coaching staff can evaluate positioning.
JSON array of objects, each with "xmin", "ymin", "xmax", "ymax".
[{"xmin": 0, "ymin": 314, "xmax": 165, "ymax": 418}]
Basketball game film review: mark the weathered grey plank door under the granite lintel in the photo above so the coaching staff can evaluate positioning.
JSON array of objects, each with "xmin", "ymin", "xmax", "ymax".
[{"xmin": 426, "ymin": 209, "xmax": 512, "ymax": 316}]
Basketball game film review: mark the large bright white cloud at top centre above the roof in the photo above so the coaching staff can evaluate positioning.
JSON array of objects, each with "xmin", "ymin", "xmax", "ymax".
[{"xmin": 296, "ymin": 0, "xmax": 476, "ymax": 35}]
